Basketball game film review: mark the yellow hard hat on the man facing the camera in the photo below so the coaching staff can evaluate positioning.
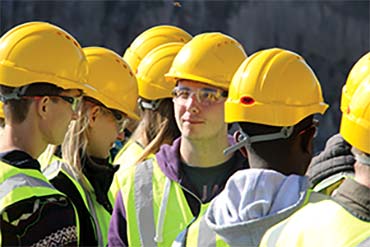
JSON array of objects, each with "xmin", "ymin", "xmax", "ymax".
[{"xmin": 166, "ymin": 33, "xmax": 247, "ymax": 90}]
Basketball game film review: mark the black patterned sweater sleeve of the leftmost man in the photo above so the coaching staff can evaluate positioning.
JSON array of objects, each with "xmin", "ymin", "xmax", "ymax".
[{"xmin": 1, "ymin": 196, "xmax": 77, "ymax": 246}]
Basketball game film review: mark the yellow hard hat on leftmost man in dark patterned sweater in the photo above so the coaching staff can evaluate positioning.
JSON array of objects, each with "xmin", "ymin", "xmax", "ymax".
[{"xmin": 0, "ymin": 22, "xmax": 88, "ymax": 89}]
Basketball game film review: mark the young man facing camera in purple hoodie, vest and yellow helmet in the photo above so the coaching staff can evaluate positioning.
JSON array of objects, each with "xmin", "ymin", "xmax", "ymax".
[{"xmin": 109, "ymin": 33, "xmax": 248, "ymax": 246}]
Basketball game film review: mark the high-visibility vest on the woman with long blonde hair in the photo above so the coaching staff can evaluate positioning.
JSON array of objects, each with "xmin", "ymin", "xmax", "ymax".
[{"xmin": 44, "ymin": 160, "xmax": 114, "ymax": 246}]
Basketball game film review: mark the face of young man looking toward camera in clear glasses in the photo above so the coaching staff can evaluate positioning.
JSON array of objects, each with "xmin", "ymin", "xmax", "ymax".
[{"xmin": 173, "ymin": 80, "xmax": 227, "ymax": 140}]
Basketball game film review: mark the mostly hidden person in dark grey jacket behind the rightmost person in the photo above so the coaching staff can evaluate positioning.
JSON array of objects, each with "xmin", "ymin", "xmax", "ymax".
[{"xmin": 307, "ymin": 52, "xmax": 370, "ymax": 195}]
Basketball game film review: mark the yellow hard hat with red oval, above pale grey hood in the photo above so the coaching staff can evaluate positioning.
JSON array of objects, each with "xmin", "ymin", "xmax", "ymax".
[{"xmin": 225, "ymin": 48, "xmax": 328, "ymax": 127}]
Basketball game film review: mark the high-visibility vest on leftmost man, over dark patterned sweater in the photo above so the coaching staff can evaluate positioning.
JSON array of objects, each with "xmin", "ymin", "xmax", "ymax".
[{"xmin": 0, "ymin": 161, "xmax": 79, "ymax": 246}]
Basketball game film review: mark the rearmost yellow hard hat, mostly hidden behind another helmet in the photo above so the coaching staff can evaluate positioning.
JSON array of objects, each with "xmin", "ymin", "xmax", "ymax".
[{"xmin": 123, "ymin": 25, "xmax": 192, "ymax": 72}]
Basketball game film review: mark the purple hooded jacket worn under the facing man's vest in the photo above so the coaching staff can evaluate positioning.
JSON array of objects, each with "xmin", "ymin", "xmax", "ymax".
[{"xmin": 108, "ymin": 136, "xmax": 249, "ymax": 246}]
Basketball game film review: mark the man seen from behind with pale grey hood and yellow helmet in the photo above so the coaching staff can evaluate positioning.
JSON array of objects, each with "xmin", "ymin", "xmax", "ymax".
[{"xmin": 174, "ymin": 48, "xmax": 328, "ymax": 247}]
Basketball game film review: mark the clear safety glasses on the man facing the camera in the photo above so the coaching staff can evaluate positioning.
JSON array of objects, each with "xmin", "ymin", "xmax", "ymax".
[{"xmin": 172, "ymin": 86, "xmax": 227, "ymax": 106}]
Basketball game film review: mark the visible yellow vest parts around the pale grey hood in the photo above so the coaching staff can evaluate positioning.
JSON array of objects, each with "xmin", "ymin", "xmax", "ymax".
[{"xmin": 172, "ymin": 190, "xmax": 327, "ymax": 247}]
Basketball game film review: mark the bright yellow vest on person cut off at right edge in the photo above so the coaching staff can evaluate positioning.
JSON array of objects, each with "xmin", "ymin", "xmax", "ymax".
[{"xmin": 261, "ymin": 199, "xmax": 370, "ymax": 247}]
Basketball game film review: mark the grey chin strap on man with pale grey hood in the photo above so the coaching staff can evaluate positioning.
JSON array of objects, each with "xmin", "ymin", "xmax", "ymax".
[{"xmin": 224, "ymin": 126, "xmax": 294, "ymax": 156}]
